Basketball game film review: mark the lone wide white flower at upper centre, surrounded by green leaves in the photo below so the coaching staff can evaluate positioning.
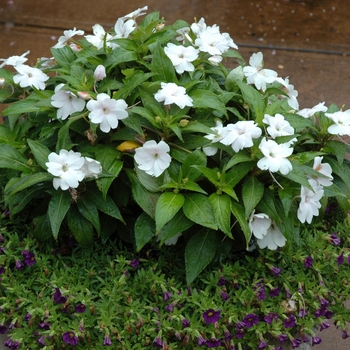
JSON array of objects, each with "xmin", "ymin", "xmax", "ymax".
[{"xmin": 154, "ymin": 83, "xmax": 193, "ymax": 108}]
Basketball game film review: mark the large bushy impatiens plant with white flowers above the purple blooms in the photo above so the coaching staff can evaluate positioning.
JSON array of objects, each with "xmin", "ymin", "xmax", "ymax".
[{"xmin": 0, "ymin": 7, "xmax": 350, "ymax": 283}]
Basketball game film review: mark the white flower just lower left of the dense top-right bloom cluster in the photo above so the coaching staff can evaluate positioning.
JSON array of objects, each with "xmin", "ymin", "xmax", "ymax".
[{"xmin": 164, "ymin": 43, "xmax": 198, "ymax": 74}]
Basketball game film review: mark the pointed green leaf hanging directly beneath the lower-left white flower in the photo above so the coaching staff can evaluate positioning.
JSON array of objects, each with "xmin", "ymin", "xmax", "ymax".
[{"xmin": 48, "ymin": 191, "xmax": 72, "ymax": 239}]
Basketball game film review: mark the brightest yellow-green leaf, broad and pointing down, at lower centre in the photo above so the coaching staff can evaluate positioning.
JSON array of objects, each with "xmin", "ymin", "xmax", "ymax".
[{"xmin": 156, "ymin": 192, "xmax": 185, "ymax": 232}]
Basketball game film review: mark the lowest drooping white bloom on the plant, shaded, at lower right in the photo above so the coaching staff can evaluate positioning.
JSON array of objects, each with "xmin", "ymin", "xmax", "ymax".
[{"xmin": 249, "ymin": 210, "xmax": 287, "ymax": 250}]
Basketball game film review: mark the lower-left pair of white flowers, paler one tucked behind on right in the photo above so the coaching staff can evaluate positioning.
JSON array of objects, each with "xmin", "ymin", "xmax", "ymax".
[{"xmin": 45, "ymin": 149, "xmax": 102, "ymax": 190}]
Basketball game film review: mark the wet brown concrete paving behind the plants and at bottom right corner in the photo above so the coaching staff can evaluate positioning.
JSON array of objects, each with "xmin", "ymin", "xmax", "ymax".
[{"xmin": 0, "ymin": 0, "xmax": 350, "ymax": 350}]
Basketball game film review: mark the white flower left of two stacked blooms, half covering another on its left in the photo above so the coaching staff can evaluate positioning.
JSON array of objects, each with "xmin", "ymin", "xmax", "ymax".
[{"xmin": 220, "ymin": 120, "xmax": 262, "ymax": 152}]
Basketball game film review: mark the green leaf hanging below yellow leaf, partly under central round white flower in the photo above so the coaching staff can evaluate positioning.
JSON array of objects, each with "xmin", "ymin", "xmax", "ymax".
[{"xmin": 126, "ymin": 169, "xmax": 160, "ymax": 219}]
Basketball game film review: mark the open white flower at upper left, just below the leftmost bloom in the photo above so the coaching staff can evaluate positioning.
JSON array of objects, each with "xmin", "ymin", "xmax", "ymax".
[{"xmin": 13, "ymin": 64, "xmax": 49, "ymax": 90}]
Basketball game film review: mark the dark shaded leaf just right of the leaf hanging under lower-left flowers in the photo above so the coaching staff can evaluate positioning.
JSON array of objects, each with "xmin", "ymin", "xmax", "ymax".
[{"xmin": 67, "ymin": 206, "xmax": 94, "ymax": 246}]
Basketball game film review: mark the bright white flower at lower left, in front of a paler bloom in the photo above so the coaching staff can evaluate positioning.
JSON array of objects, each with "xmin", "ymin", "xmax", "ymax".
[{"xmin": 45, "ymin": 149, "xmax": 85, "ymax": 190}]
